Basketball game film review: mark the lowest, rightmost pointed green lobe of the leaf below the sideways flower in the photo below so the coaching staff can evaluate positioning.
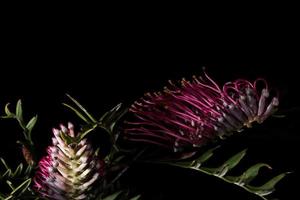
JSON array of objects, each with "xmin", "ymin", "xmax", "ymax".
[{"xmin": 246, "ymin": 173, "xmax": 289, "ymax": 196}]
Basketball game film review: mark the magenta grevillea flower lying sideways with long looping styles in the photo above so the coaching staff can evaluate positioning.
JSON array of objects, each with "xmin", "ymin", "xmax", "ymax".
[{"xmin": 125, "ymin": 72, "xmax": 279, "ymax": 151}]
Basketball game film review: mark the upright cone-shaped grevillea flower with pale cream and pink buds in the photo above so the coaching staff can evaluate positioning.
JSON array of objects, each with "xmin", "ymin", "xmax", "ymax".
[{"xmin": 34, "ymin": 123, "xmax": 104, "ymax": 200}]
